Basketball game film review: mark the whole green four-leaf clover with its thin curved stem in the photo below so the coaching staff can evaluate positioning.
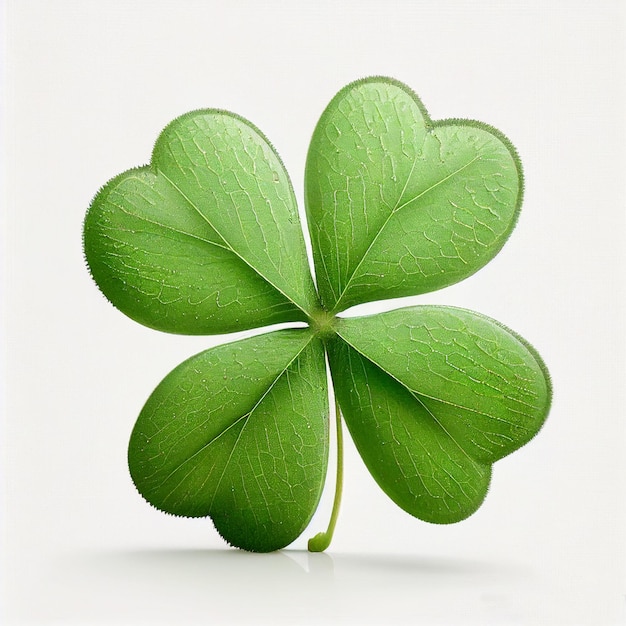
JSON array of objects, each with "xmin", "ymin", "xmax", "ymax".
[{"xmin": 84, "ymin": 77, "xmax": 551, "ymax": 552}]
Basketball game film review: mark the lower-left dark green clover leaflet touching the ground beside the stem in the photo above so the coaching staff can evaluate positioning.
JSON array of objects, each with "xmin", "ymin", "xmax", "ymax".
[{"xmin": 129, "ymin": 329, "xmax": 328, "ymax": 552}]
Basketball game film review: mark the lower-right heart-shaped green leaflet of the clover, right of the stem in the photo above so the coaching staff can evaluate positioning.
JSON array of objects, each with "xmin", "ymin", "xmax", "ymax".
[{"xmin": 330, "ymin": 306, "xmax": 551, "ymax": 523}]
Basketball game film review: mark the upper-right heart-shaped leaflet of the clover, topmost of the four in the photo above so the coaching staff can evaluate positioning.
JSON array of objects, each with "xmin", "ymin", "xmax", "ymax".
[{"xmin": 305, "ymin": 77, "xmax": 522, "ymax": 312}]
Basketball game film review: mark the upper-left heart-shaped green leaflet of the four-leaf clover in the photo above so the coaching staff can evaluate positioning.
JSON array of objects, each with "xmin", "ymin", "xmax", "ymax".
[{"xmin": 84, "ymin": 110, "xmax": 316, "ymax": 334}]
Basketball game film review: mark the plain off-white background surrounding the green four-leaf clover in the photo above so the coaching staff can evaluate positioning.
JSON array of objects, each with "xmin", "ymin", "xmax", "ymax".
[{"xmin": 0, "ymin": 0, "xmax": 626, "ymax": 626}]
